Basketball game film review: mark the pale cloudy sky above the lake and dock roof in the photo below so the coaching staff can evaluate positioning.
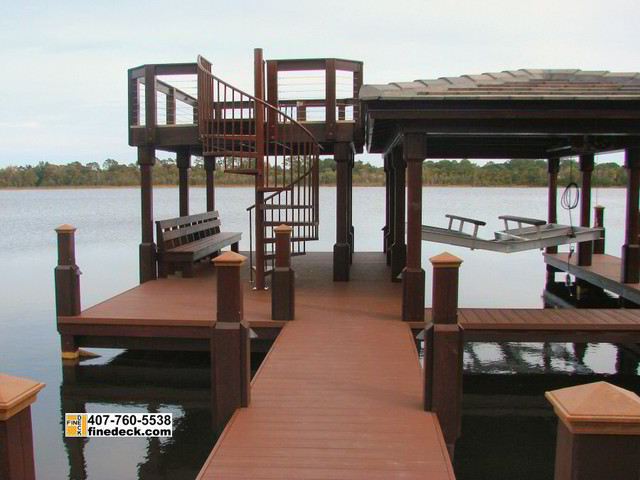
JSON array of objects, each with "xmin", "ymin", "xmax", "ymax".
[{"xmin": 0, "ymin": 0, "xmax": 640, "ymax": 167}]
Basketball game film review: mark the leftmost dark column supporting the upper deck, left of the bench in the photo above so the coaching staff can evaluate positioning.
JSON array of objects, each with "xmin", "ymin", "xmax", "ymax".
[{"xmin": 138, "ymin": 146, "xmax": 157, "ymax": 283}]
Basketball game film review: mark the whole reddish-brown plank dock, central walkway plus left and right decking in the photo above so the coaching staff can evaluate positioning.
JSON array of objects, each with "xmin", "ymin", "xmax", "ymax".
[{"xmin": 58, "ymin": 253, "xmax": 640, "ymax": 479}]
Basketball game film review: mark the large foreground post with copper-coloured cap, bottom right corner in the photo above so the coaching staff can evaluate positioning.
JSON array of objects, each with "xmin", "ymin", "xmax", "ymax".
[{"xmin": 545, "ymin": 382, "xmax": 640, "ymax": 480}]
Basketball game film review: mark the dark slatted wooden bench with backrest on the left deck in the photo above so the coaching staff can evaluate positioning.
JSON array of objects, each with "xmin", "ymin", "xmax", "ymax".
[{"xmin": 156, "ymin": 212, "xmax": 242, "ymax": 277}]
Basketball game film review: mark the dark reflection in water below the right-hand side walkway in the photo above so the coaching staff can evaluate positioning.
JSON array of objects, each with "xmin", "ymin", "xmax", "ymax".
[{"xmin": 454, "ymin": 342, "xmax": 640, "ymax": 480}]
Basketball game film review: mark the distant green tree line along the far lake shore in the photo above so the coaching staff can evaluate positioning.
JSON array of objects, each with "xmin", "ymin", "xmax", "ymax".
[{"xmin": 0, "ymin": 157, "xmax": 627, "ymax": 188}]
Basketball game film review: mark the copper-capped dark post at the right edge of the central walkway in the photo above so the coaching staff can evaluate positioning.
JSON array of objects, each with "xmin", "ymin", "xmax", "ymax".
[{"xmin": 424, "ymin": 252, "xmax": 464, "ymax": 459}]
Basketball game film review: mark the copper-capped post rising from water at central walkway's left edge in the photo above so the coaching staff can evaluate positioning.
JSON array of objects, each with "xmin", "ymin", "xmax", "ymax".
[{"xmin": 211, "ymin": 252, "xmax": 251, "ymax": 433}]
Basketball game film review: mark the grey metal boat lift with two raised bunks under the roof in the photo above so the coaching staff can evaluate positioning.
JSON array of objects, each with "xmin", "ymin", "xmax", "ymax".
[{"xmin": 422, "ymin": 214, "xmax": 601, "ymax": 253}]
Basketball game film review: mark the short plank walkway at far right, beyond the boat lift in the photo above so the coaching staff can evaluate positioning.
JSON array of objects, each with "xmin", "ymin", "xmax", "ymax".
[{"xmin": 543, "ymin": 253, "xmax": 640, "ymax": 304}]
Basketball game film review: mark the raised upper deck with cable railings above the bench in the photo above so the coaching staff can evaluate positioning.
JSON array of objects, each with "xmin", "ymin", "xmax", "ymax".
[{"xmin": 128, "ymin": 58, "xmax": 364, "ymax": 155}]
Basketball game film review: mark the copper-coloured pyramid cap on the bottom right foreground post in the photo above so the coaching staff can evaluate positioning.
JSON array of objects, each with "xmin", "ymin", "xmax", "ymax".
[{"xmin": 545, "ymin": 382, "xmax": 640, "ymax": 435}]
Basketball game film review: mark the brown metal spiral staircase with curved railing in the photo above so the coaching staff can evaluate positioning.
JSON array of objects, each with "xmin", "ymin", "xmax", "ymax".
[{"xmin": 192, "ymin": 56, "xmax": 320, "ymax": 289}]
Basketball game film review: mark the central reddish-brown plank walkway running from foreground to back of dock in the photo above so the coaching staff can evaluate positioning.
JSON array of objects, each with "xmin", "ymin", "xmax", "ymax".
[{"xmin": 198, "ymin": 254, "xmax": 454, "ymax": 480}]
